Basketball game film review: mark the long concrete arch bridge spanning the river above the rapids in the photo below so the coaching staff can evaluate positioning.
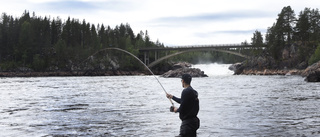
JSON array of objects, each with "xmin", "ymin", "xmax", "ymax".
[{"xmin": 139, "ymin": 44, "xmax": 264, "ymax": 68}]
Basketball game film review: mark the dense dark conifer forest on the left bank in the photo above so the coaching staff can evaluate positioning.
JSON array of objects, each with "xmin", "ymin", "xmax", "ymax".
[{"xmin": 0, "ymin": 11, "xmax": 163, "ymax": 71}]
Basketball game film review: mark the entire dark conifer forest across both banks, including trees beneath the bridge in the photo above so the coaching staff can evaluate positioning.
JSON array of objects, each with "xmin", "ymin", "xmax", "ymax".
[{"xmin": 0, "ymin": 6, "xmax": 320, "ymax": 72}]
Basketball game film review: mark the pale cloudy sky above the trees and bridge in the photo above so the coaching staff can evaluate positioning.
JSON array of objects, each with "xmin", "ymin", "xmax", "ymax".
[{"xmin": 0, "ymin": 0, "xmax": 320, "ymax": 46}]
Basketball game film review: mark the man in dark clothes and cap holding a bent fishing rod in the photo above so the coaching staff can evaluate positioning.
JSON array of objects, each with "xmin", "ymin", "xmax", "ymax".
[{"xmin": 166, "ymin": 74, "xmax": 200, "ymax": 137}]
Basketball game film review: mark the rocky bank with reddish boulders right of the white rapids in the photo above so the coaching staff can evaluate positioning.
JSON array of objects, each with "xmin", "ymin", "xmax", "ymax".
[{"xmin": 229, "ymin": 42, "xmax": 320, "ymax": 82}]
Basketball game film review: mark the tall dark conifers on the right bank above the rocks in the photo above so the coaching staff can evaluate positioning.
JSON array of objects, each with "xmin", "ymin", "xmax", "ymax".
[{"xmin": 252, "ymin": 6, "xmax": 320, "ymax": 67}]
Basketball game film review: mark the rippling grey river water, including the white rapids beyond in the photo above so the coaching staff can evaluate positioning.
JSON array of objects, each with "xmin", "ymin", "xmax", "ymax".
[{"xmin": 0, "ymin": 64, "xmax": 320, "ymax": 137}]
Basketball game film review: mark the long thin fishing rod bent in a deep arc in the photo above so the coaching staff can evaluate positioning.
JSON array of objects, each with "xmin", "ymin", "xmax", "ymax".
[{"xmin": 80, "ymin": 48, "xmax": 174, "ymax": 106}]
